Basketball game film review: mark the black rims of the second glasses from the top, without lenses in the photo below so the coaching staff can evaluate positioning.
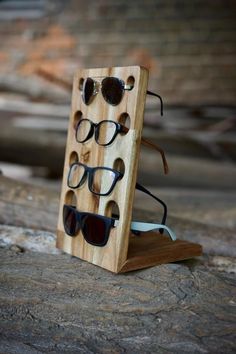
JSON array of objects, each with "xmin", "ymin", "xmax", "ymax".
[{"xmin": 75, "ymin": 118, "xmax": 127, "ymax": 146}]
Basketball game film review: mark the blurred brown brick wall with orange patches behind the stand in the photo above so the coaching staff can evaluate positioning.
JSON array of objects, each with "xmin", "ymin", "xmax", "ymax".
[{"xmin": 0, "ymin": 0, "xmax": 236, "ymax": 104}]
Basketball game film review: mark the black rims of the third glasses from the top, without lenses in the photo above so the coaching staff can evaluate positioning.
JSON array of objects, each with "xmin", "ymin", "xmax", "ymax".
[{"xmin": 67, "ymin": 162, "xmax": 123, "ymax": 196}]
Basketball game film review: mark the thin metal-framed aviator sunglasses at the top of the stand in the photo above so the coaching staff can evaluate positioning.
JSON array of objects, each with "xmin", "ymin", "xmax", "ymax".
[{"xmin": 82, "ymin": 77, "xmax": 163, "ymax": 115}]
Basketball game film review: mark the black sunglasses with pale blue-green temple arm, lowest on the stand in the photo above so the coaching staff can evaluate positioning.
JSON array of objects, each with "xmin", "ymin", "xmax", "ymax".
[{"xmin": 63, "ymin": 204, "xmax": 176, "ymax": 247}]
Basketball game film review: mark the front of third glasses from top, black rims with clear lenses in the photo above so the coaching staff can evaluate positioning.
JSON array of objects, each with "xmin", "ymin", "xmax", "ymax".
[{"xmin": 67, "ymin": 162, "xmax": 123, "ymax": 196}]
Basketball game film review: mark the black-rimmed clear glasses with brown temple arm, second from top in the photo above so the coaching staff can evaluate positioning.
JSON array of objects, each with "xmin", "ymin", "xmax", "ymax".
[{"xmin": 75, "ymin": 118, "xmax": 168, "ymax": 174}]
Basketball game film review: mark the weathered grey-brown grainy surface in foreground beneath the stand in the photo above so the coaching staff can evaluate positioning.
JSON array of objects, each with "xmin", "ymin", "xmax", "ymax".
[{"xmin": 0, "ymin": 249, "xmax": 235, "ymax": 354}]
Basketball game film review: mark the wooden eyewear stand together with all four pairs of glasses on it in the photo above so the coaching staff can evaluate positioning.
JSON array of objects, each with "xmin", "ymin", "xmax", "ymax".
[{"xmin": 57, "ymin": 66, "xmax": 199, "ymax": 273}]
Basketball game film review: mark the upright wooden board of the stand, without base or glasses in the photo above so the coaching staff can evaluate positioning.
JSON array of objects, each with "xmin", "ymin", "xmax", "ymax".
[{"xmin": 57, "ymin": 67, "xmax": 148, "ymax": 272}]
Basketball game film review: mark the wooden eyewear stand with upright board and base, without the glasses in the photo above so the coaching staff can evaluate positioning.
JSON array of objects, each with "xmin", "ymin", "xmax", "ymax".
[{"xmin": 57, "ymin": 66, "xmax": 202, "ymax": 273}]
